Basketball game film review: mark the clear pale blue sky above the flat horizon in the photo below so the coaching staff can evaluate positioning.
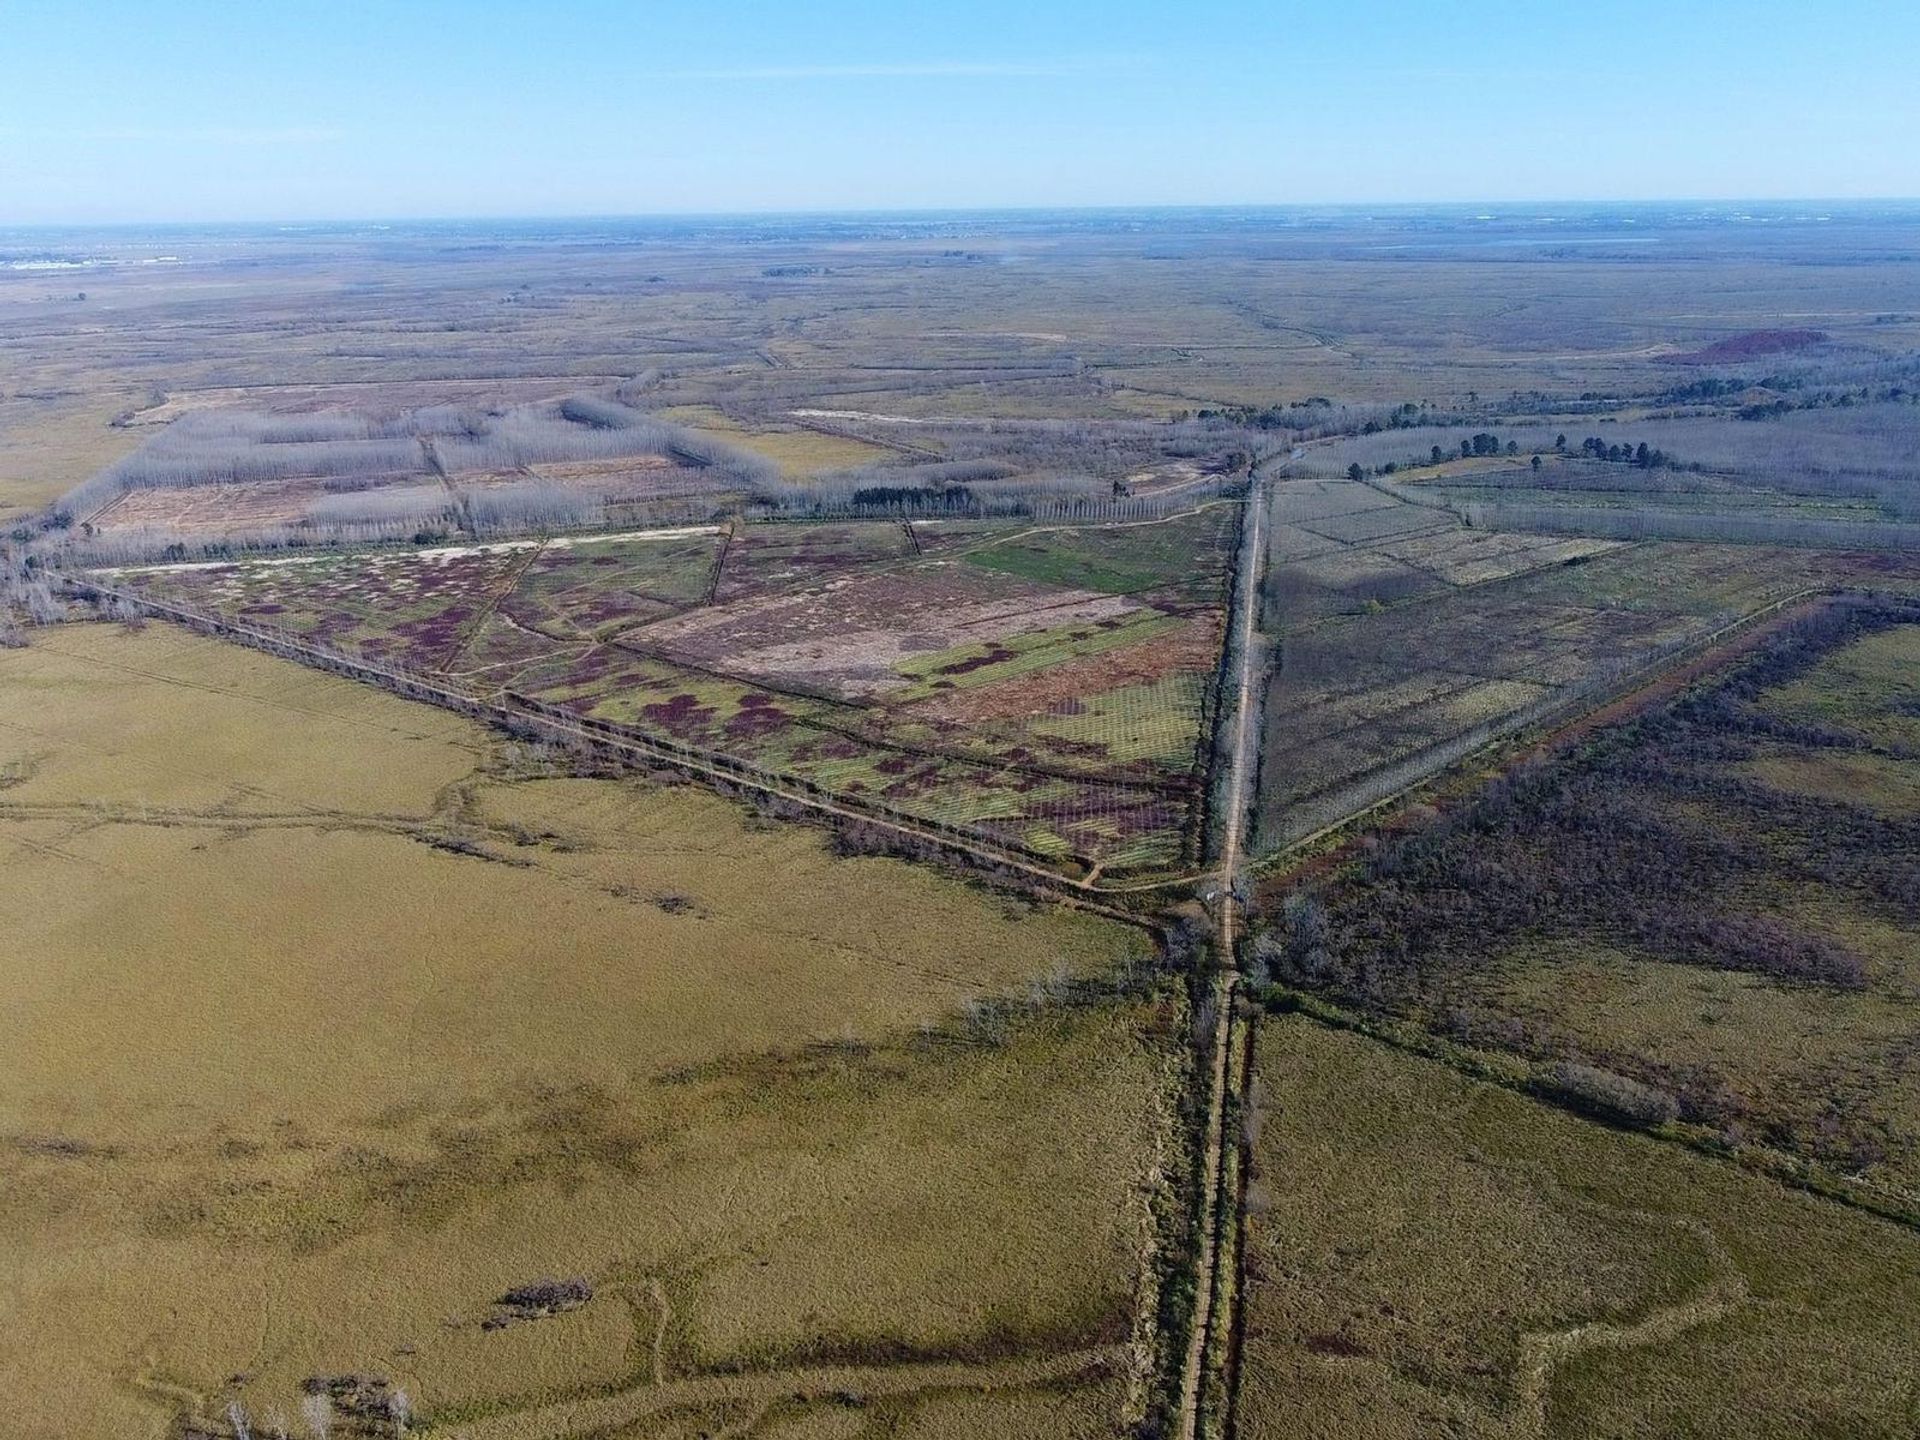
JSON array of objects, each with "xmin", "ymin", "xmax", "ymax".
[{"xmin": 0, "ymin": 0, "xmax": 1920, "ymax": 225}]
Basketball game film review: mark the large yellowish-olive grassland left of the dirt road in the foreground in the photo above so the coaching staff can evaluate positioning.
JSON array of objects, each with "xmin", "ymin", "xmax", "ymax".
[{"xmin": 0, "ymin": 626, "xmax": 1181, "ymax": 1440}]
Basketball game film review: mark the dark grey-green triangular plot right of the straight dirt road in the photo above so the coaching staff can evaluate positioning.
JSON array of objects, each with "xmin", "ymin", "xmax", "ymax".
[{"xmin": 1260, "ymin": 532, "xmax": 1849, "ymax": 847}]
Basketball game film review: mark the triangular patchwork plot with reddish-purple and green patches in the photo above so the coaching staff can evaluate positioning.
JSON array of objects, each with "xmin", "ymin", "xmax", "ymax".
[{"xmin": 104, "ymin": 503, "xmax": 1236, "ymax": 872}]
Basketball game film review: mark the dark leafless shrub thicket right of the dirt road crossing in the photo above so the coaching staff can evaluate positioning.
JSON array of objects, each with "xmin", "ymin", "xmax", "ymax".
[{"xmin": 1260, "ymin": 599, "xmax": 1920, "ymax": 1164}]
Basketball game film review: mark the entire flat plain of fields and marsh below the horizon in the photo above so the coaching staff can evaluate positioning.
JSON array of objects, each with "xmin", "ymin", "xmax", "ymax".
[{"xmin": 11, "ymin": 205, "xmax": 1920, "ymax": 1440}]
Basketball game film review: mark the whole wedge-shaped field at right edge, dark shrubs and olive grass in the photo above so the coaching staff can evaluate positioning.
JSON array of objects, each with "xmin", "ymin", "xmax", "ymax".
[{"xmin": 1251, "ymin": 599, "xmax": 1920, "ymax": 1208}]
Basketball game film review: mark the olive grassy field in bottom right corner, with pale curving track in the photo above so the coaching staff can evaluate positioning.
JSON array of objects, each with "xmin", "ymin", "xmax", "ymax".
[{"xmin": 1236, "ymin": 1018, "xmax": 1920, "ymax": 1440}]
